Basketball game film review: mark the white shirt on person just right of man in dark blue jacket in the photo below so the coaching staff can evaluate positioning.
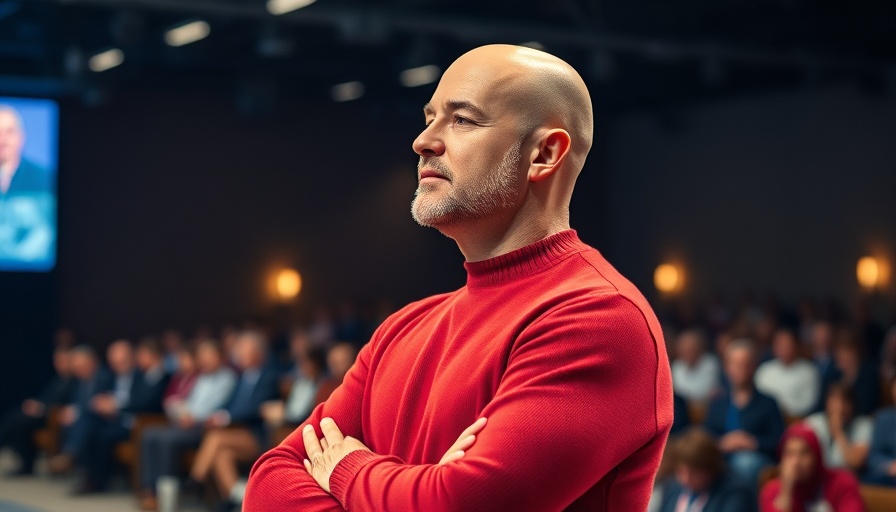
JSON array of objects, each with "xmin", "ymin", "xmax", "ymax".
[{"xmin": 755, "ymin": 359, "xmax": 821, "ymax": 416}]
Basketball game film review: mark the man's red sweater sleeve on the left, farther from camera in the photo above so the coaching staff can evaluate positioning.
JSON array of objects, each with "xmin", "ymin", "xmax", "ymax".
[{"xmin": 243, "ymin": 342, "xmax": 373, "ymax": 512}]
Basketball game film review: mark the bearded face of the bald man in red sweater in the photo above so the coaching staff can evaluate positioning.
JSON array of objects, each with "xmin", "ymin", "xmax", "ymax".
[{"xmin": 411, "ymin": 64, "xmax": 525, "ymax": 227}]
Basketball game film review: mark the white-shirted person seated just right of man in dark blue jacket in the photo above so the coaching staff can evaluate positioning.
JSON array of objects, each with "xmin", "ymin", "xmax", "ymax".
[{"xmin": 756, "ymin": 328, "xmax": 821, "ymax": 418}]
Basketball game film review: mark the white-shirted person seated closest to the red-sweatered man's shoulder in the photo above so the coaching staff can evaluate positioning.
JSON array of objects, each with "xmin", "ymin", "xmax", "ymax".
[{"xmin": 672, "ymin": 328, "xmax": 719, "ymax": 403}]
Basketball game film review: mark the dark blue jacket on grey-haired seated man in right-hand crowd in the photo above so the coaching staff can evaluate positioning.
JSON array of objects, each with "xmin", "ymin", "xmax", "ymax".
[{"xmin": 705, "ymin": 389, "xmax": 785, "ymax": 458}]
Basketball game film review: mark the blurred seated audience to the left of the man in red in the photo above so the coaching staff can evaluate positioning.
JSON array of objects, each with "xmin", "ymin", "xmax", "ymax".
[{"xmin": 0, "ymin": 307, "xmax": 382, "ymax": 510}]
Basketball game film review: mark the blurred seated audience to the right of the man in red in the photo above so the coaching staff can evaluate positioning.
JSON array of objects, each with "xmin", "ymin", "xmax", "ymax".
[{"xmin": 651, "ymin": 296, "xmax": 896, "ymax": 512}]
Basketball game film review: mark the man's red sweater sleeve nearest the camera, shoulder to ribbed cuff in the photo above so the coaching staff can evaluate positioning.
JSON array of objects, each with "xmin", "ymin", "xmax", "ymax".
[{"xmin": 326, "ymin": 295, "xmax": 672, "ymax": 512}]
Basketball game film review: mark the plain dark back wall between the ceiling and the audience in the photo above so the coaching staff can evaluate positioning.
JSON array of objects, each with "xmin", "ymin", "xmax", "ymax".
[{"xmin": 0, "ymin": 82, "xmax": 896, "ymax": 405}]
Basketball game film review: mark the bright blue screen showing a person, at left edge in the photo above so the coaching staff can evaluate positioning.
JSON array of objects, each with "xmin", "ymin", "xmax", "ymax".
[{"xmin": 0, "ymin": 96, "xmax": 59, "ymax": 272}]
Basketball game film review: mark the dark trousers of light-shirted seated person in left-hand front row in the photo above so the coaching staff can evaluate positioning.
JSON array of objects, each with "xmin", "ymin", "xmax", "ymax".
[{"xmin": 140, "ymin": 426, "xmax": 203, "ymax": 492}]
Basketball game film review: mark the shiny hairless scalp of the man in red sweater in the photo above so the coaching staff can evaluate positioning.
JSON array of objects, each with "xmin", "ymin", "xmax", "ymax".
[{"xmin": 443, "ymin": 44, "xmax": 594, "ymax": 172}]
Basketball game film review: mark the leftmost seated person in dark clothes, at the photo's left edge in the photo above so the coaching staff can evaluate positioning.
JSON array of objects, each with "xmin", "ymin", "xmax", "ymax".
[{"xmin": 0, "ymin": 346, "xmax": 75, "ymax": 475}]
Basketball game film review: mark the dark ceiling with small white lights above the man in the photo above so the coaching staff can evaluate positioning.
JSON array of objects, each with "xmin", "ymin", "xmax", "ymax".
[{"xmin": 0, "ymin": 0, "xmax": 896, "ymax": 113}]
